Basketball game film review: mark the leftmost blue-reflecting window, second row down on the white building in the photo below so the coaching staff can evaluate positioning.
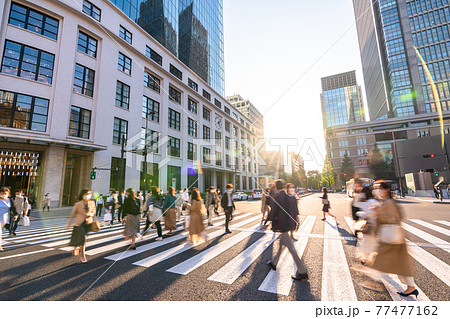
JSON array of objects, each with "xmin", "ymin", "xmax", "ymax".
[{"xmin": 1, "ymin": 41, "xmax": 55, "ymax": 84}]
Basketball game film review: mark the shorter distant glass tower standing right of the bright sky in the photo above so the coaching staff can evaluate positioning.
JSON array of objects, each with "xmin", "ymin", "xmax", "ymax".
[{"xmin": 320, "ymin": 71, "xmax": 365, "ymax": 129}]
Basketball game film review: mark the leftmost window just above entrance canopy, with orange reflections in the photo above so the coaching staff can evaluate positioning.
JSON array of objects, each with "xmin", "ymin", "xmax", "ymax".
[{"xmin": 0, "ymin": 90, "xmax": 49, "ymax": 132}]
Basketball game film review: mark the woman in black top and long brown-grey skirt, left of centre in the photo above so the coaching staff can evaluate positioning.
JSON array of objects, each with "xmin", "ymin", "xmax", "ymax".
[{"xmin": 122, "ymin": 188, "xmax": 141, "ymax": 250}]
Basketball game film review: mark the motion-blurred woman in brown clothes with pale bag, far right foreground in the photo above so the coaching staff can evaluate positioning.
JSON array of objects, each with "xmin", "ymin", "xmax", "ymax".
[{"xmin": 371, "ymin": 182, "xmax": 419, "ymax": 297}]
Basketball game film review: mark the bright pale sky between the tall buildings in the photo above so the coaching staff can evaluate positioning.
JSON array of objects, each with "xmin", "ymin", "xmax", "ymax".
[{"xmin": 224, "ymin": 0, "xmax": 364, "ymax": 170}]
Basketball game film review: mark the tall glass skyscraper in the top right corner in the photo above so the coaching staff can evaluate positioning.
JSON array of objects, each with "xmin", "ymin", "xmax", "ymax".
[{"xmin": 353, "ymin": 0, "xmax": 450, "ymax": 120}]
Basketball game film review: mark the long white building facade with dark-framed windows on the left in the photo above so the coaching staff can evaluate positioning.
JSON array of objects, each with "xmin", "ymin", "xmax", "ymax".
[{"xmin": 0, "ymin": 0, "xmax": 258, "ymax": 207}]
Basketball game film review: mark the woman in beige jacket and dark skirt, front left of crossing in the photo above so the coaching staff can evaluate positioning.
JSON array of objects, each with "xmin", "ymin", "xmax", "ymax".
[{"xmin": 67, "ymin": 188, "xmax": 95, "ymax": 263}]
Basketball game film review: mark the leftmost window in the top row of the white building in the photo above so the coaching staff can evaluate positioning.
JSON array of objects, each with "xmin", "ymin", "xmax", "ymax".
[{"xmin": 8, "ymin": 3, "xmax": 59, "ymax": 40}]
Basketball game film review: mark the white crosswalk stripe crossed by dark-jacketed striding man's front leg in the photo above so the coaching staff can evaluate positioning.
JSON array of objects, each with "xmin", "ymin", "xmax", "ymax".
[{"xmin": 258, "ymin": 216, "xmax": 316, "ymax": 296}]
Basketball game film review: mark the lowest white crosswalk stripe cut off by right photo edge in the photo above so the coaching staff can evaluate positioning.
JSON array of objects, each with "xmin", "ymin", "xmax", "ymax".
[{"xmin": 406, "ymin": 240, "xmax": 450, "ymax": 286}]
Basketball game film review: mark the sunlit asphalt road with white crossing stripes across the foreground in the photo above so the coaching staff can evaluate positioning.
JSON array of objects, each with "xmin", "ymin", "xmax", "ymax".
[{"xmin": 0, "ymin": 194, "xmax": 450, "ymax": 301}]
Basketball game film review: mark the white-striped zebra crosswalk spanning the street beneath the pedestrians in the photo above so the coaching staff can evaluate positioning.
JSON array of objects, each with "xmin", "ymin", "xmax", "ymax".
[{"xmin": 0, "ymin": 211, "xmax": 450, "ymax": 301}]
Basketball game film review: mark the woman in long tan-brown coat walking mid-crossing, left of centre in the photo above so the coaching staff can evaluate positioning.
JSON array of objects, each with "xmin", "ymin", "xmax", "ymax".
[{"xmin": 188, "ymin": 189, "xmax": 206, "ymax": 245}]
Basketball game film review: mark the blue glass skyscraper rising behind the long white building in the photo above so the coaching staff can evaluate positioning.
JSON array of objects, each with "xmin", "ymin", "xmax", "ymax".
[{"xmin": 110, "ymin": 0, "xmax": 225, "ymax": 95}]
